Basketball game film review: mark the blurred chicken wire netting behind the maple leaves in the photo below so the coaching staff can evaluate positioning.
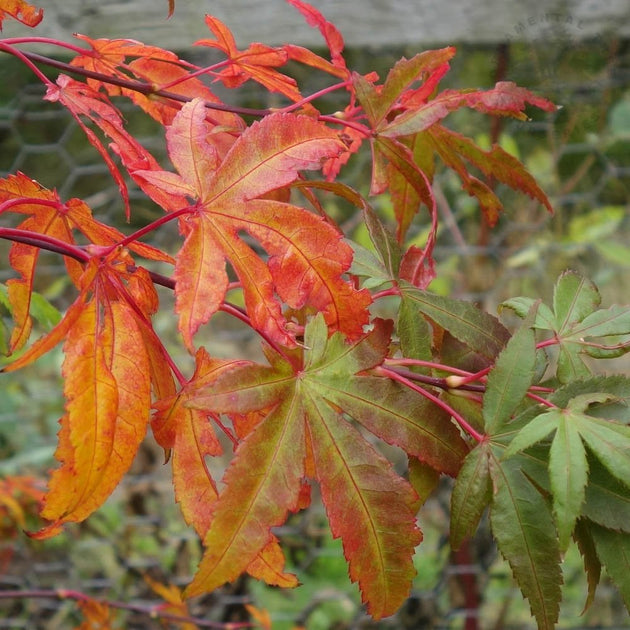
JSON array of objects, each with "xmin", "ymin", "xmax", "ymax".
[{"xmin": 0, "ymin": 30, "xmax": 630, "ymax": 630}]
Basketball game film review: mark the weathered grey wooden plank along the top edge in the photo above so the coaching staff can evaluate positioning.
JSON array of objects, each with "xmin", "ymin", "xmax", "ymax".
[{"xmin": 3, "ymin": 0, "xmax": 630, "ymax": 50}]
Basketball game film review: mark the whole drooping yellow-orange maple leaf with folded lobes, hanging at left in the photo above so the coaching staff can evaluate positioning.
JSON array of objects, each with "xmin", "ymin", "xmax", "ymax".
[{"xmin": 4, "ymin": 248, "xmax": 173, "ymax": 538}]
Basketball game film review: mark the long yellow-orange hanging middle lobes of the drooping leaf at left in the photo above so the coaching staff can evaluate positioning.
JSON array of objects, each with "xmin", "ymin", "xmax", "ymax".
[{"xmin": 38, "ymin": 302, "xmax": 150, "ymax": 538}]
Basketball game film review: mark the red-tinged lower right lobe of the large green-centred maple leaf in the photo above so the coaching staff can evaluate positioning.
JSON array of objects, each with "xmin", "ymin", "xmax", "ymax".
[{"xmin": 305, "ymin": 398, "xmax": 422, "ymax": 619}]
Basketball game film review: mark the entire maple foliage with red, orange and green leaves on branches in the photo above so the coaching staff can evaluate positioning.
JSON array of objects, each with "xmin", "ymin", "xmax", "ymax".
[{"xmin": 0, "ymin": 0, "xmax": 630, "ymax": 628}]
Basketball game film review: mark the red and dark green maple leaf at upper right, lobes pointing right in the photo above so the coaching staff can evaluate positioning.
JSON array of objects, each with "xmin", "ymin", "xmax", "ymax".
[{"xmin": 353, "ymin": 66, "xmax": 556, "ymax": 242}]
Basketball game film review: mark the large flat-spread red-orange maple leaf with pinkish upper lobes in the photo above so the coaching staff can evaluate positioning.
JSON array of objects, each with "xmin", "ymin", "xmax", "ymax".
[{"xmin": 136, "ymin": 99, "xmax": 370, "ymax": 350}]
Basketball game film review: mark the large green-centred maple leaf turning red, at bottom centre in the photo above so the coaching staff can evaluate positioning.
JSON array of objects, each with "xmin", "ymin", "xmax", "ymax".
[{"xmin": 186, "ymin": 314, "xmax": 468, "ymax": 618}]
